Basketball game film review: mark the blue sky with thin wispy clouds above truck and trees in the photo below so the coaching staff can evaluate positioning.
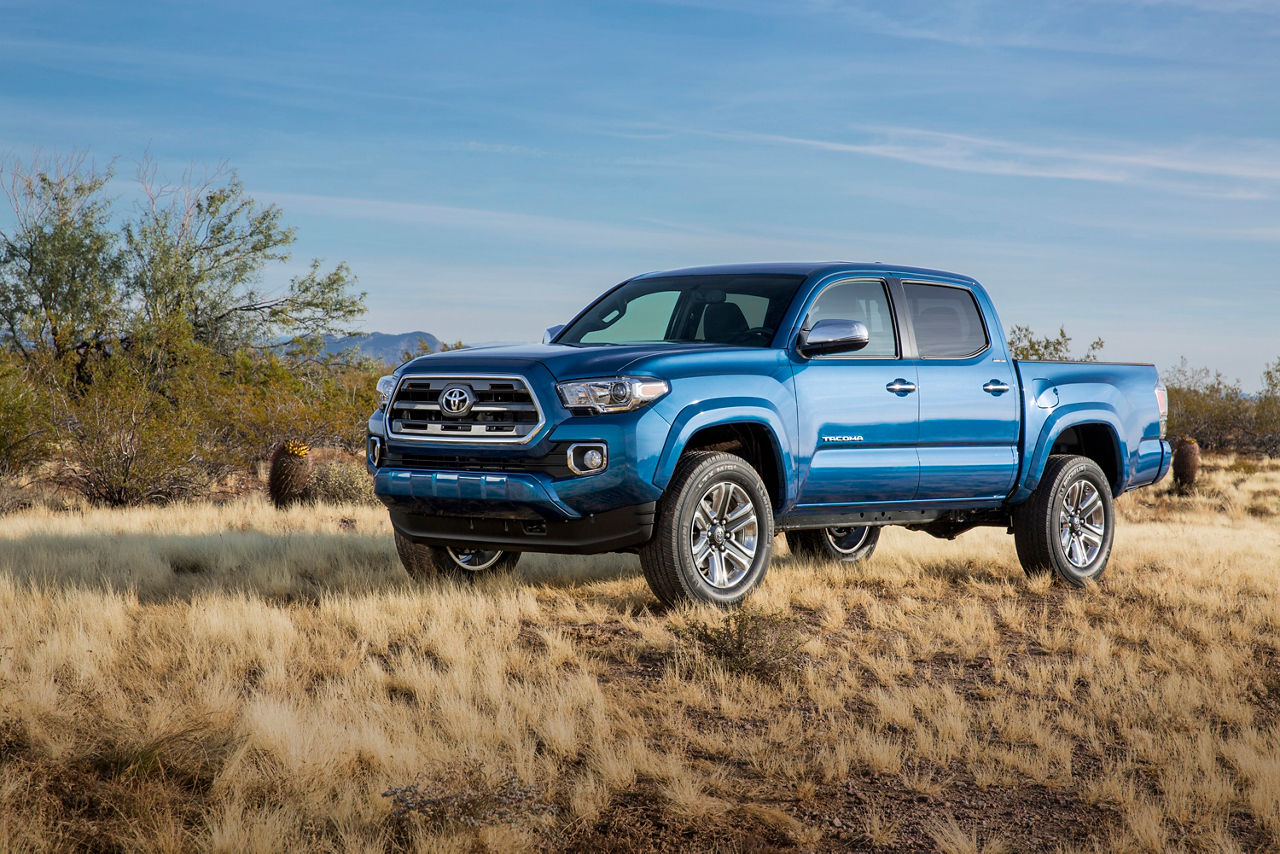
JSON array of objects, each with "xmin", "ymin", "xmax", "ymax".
[{"xmin": 0, "ymin": 0, "xmax": 1280, "ymax": 388}]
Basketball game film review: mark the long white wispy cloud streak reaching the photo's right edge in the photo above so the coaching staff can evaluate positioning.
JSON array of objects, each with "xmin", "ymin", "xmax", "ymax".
[{"xmin": 704, "ymin": 128, "xmax": 1280, "ymax": 198}]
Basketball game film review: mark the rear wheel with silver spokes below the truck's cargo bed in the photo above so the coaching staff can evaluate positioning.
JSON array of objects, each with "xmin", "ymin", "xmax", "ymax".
[{"xmin": 1014, "ymin": 456, "xmax": 1115, "ymax": 586}]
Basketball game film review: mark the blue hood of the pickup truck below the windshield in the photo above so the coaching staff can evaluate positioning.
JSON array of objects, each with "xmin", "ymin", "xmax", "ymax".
[{"xmin": 404, "ymin": 343, "xmax": 723, "ymax": 379}]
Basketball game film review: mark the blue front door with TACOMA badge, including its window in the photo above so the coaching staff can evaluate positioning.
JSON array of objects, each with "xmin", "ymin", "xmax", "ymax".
[{"xmin": 792, "ymin": 279, "xmax": 919, "ymax": 506}]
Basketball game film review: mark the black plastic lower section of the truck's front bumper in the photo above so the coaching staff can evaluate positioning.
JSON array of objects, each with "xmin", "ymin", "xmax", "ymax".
[{"xmin": 390, "ymin": 502, "xmax": 657, "ymax": 554}]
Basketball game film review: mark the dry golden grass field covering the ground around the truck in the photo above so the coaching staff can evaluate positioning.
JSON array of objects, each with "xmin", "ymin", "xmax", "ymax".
[{"xmin": 0, "ymin": 457, "xmax": 1280, "ymax": 851}]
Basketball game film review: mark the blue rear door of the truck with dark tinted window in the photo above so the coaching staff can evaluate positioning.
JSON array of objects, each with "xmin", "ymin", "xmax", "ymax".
[{"xmin": 902, "ymin": 282, "xmax": 1020, "ymax": 501}]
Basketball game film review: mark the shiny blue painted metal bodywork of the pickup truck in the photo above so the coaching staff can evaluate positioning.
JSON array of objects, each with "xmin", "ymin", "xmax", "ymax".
[{"xmin": 369, "ymin": 262, "xmax": 1171, "ymax": 547}]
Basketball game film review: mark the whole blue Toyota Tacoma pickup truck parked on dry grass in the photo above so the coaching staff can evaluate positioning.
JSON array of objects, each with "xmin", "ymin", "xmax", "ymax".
[{"xmin": 367, "ymin": 262, "xmax": 1171, "ymax": 606}]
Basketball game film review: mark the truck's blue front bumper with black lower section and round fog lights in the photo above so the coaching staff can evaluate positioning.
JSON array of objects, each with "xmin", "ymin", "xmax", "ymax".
[{"xmin": 367, "ymin": 365, "xmax": 671, "ymax": 553}]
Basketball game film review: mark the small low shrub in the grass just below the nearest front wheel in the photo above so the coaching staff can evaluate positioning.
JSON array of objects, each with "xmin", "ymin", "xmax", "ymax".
[{"xmin": 678, "ymin": 607, "xmax": 809, "ymax": 681}]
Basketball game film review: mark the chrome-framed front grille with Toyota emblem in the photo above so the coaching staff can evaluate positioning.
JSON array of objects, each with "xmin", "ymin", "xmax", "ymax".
[{"xmin": 387, "ymin": 374, "xmax": 544, "ymax": 444}]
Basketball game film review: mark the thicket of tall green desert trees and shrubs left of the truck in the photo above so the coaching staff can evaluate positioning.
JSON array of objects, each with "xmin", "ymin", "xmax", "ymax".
[{"xmin": 0, "ymin": 156, "xmax": 379, "ymax": 504}]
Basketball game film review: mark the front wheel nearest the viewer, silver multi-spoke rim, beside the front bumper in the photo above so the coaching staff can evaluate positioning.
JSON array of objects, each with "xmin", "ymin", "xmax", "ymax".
[{"xmin": 640, "ymin": 451, "xmax": 773, "ymax": 607}]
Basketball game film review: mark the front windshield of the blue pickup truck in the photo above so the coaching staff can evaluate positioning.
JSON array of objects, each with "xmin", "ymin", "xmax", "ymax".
[{"xmin": 556, "ymin": 274, "xmax": 804, "ymax": 347}]
